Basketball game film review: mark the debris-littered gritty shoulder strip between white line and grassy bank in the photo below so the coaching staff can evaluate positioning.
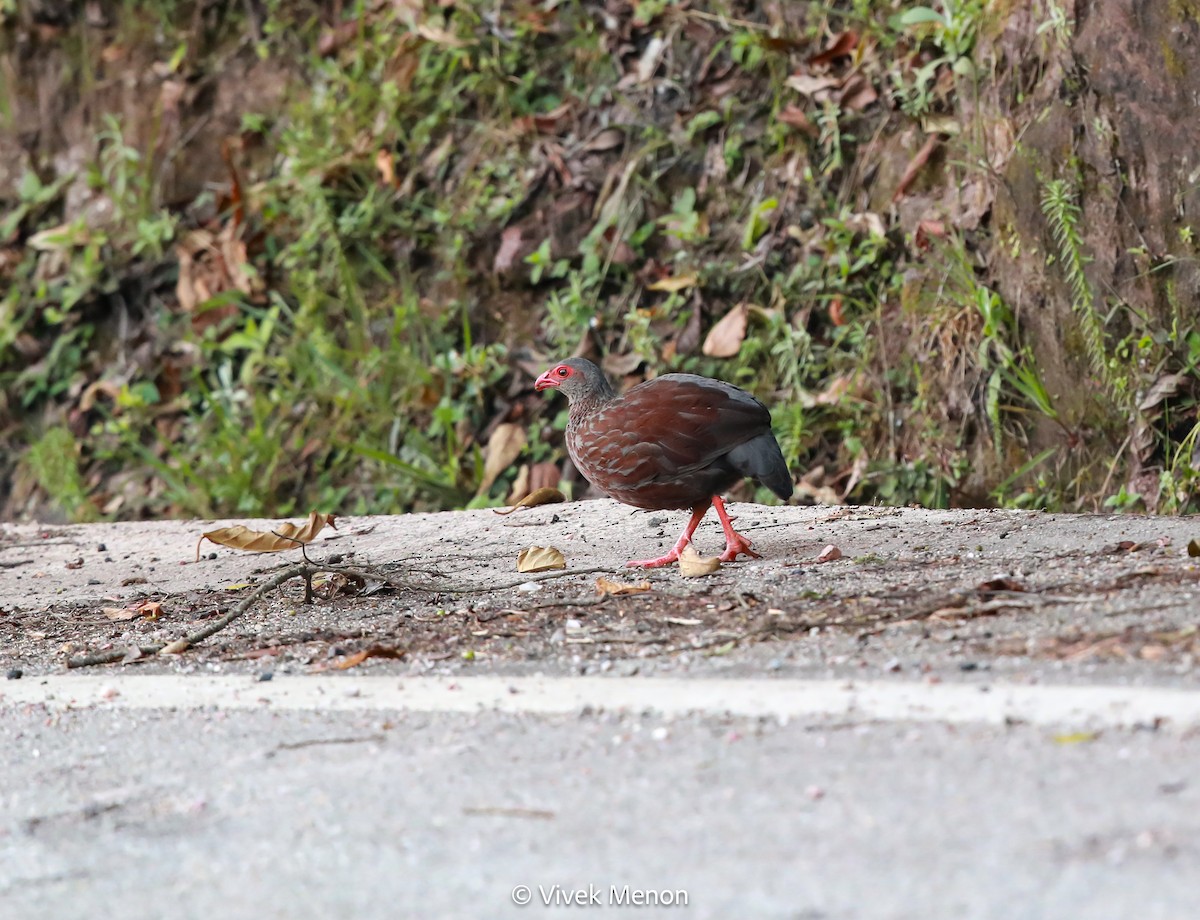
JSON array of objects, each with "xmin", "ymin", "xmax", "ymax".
[{"xmin": 0, "ymin": 500, "xmax": 1200, "ymax": 685}]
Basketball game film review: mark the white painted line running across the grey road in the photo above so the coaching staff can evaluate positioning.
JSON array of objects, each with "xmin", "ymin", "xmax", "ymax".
[{"xmin": 0, "ymin": 674, "xmax": 1200, "ymax": 732}]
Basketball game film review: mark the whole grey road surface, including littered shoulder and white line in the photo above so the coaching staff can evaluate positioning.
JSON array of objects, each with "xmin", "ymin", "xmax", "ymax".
[{"xmin": 0, "ymin": 503, "xmax": 1200, "ymax": 920}]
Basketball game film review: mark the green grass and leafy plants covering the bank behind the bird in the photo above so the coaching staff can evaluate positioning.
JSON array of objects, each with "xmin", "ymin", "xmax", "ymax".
[{"xmin": 0, "ymin": 0, "xmax": 1176, "ymax": 518}]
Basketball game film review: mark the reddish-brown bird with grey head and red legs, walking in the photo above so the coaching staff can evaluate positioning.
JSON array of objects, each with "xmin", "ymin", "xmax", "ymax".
[{"xmin": 534, "ymin": 357, "xmax": 792, "ymax": 567}]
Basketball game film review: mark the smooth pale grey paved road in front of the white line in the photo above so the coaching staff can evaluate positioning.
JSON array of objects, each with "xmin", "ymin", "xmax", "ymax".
[{"xmin": 0, "ymin": 677, "xmax": 1200, "ymax": 920}]
